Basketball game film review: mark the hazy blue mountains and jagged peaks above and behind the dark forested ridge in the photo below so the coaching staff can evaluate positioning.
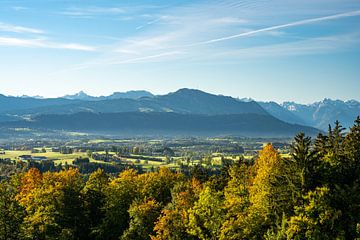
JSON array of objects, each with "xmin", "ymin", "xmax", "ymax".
[{"xmin": 0, "ymin": 88, "xmax": 360, "ymax": 133}]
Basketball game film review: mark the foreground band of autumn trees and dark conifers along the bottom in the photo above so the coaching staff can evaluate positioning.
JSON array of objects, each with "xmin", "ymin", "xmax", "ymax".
[{"xmin": 0, "ymin": 118, "xmax": 360, "ymax": 240}]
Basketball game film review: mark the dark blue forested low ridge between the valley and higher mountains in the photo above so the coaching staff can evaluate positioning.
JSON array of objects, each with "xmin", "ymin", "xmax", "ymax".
[{"xmin": 0, "ymin": 112, "xmax": 319, "ymax": 137}]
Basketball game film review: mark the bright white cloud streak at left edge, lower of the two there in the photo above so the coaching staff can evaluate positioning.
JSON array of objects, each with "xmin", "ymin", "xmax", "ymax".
[{"xmin": 0, "ymin": 36, "xmax": 96, "ymax": 52}]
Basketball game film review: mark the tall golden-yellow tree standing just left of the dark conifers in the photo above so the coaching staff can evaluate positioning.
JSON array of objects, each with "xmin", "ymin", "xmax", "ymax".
[{"xmin": 240, "ymin": 144, "xmax": 294, "ymax": 239}]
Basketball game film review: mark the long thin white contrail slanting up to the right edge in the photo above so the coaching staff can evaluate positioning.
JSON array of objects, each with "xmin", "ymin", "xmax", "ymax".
[{"xmin": 193, "ymin": 10, "xmax": 360, "ymax": 46}]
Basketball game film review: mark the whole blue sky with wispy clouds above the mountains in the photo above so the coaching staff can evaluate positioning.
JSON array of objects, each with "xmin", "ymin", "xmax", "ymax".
[{"xmin": 0, "ymin": 0, "xmax": 360, "ymax": 103}]
